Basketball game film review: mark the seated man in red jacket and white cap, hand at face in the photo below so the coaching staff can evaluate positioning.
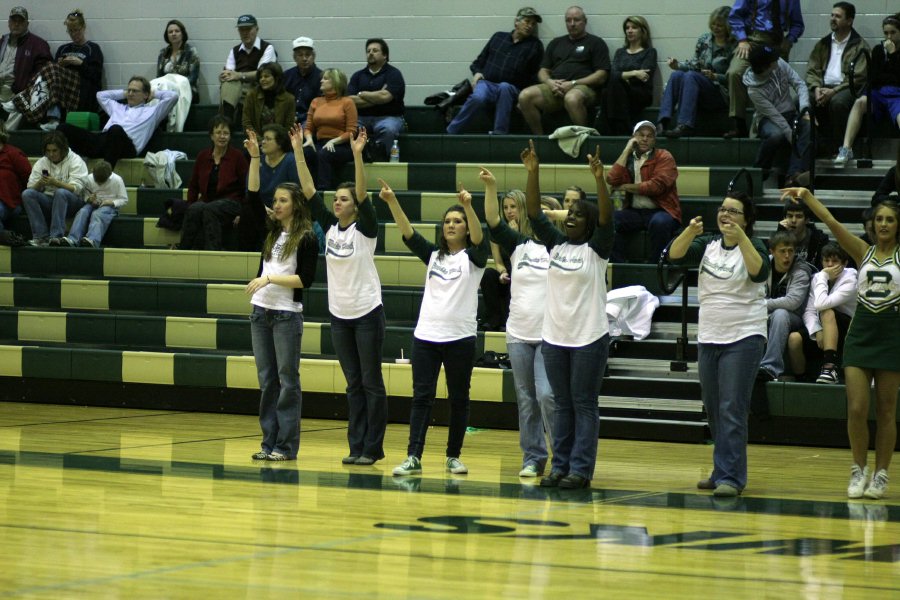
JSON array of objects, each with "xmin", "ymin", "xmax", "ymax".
[{"xmin": 606, "ymin": 121, "xmax": 681, "ymax": 263}]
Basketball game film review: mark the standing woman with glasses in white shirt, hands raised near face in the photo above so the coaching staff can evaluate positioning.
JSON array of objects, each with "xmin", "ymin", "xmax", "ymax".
[{"xmin": 669, "ymin": 192, "xmax": 769, "ymax": 496}]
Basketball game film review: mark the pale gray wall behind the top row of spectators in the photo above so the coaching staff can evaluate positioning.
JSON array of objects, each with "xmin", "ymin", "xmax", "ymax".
[{"xmin": 22, "ymin": 0, "xmax": 900, "ymax": 104}]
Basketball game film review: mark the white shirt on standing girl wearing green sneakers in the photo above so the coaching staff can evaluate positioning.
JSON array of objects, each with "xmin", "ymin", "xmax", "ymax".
[{"xmin": 413, "ymin": 250, "xmax": 484, "ymax": 342}]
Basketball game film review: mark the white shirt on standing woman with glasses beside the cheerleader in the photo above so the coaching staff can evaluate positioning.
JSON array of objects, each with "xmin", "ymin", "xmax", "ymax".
[{"xmin": 697, "ymin": 236, "xmax": 768, "ymax": 344}]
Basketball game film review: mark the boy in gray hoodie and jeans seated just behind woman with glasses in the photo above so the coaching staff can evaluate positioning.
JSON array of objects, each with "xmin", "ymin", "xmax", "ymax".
[{"xmin": 759, "ymin": 231, "xmax": 812, "ymax": 381}]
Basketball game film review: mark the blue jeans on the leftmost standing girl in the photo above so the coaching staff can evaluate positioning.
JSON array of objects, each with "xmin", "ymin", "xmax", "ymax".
[{"xmin": 250, "ymin": 306, "xmax": 303, "ymax": 458}]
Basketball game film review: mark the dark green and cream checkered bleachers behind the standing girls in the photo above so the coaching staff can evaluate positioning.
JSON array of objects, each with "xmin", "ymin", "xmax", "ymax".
[{"xmin": 0, "ymin": 106, "xmax": 888, "ymax": 445}]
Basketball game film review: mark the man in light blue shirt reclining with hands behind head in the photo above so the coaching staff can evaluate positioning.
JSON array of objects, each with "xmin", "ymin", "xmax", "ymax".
[{"xmin": 58, "ymin": 75, "xmax": 178, "ymax": 169}]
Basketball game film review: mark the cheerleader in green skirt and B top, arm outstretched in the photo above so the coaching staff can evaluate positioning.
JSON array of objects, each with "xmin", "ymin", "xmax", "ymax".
[{"xmin": 783, "ymin": 188, "xmax": 900, "ymax": 500}]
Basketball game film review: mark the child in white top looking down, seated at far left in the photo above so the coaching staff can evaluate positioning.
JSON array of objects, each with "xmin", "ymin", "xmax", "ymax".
[{"xmin": 60, "ymin": 160, "xmax": 128, "ymax": 248}]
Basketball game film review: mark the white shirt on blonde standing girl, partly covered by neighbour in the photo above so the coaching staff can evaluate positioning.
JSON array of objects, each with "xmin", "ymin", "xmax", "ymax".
[{"xmin": 506, "ymin": 240, "xmax": 550, "ymax": 342}]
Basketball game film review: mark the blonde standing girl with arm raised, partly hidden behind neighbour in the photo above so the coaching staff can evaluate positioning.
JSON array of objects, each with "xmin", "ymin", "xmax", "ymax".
[{"xmin": 479, "ymin": 167, "xmax": 553, "ymax": 477}]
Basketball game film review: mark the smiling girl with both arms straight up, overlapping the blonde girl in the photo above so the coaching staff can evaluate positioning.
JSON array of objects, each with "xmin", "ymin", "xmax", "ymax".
[{"xmin": 522, "ymin": 140, "xmax": 613, "ymax": 488}]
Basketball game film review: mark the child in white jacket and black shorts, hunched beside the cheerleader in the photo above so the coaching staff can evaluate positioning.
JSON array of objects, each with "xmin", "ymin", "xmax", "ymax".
[{"xmin": 788, "ymin": 242, "xmax": 856, "ymax": 383}]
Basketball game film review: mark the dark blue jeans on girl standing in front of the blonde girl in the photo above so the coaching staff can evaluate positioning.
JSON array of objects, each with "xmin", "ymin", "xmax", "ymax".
[{"xmin": 541, "ymin": 334, "xmax": 609, "ymax": 479}]
